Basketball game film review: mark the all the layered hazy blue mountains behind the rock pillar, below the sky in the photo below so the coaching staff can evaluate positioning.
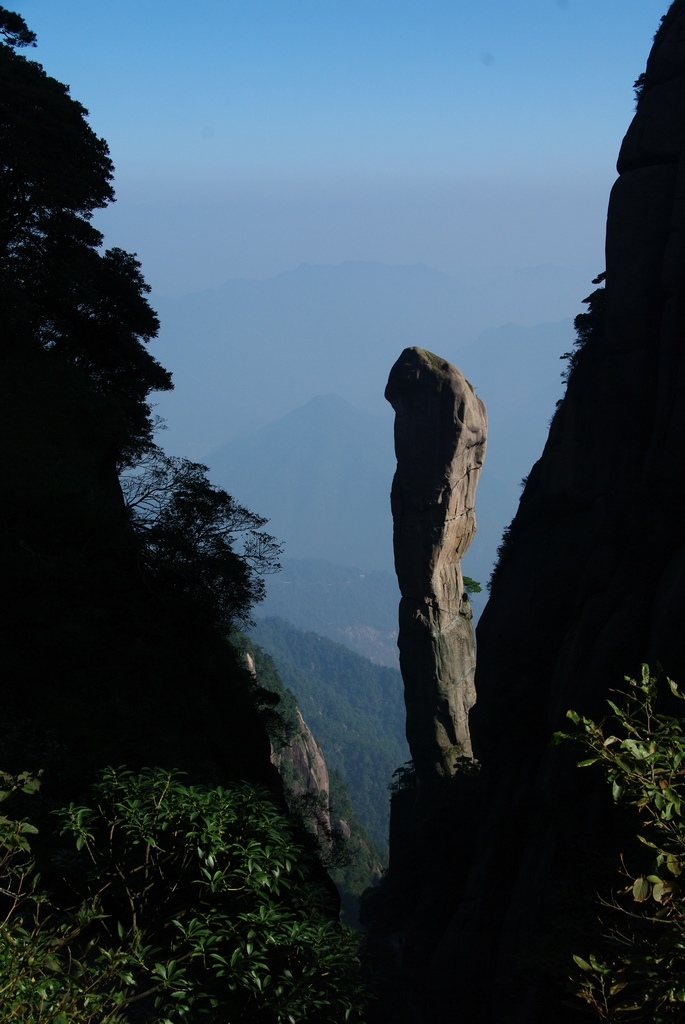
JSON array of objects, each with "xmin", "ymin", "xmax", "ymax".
[{"xmin": 148, "ymin": 262, "xmax": 577, "ymax": 625}]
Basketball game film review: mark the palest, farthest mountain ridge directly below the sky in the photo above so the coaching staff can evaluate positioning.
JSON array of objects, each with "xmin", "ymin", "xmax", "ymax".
[{"xmin": 151, "ymin": 261, "xmax": 581, "ymax": 459}]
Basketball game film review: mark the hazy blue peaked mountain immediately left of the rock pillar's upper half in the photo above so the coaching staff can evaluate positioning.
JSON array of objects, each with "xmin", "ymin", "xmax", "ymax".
[{"xmin": 209, "ymin": 394, "xmax": 394, "ymax": 569}]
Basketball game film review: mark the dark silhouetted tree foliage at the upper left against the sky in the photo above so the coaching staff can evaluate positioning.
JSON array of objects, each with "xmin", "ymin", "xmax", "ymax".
[{"xmin": 0, "ymin": 8, "xmax": 171, "ymax": 461}]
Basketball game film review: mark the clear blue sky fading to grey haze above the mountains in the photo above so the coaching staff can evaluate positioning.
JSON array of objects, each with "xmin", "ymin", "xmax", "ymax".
[{"xmin": 14, "ymin": 0, "xmax": 668, "ymax": 294}]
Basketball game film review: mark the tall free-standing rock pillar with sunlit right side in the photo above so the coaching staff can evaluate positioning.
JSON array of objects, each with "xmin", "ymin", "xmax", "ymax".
[{"xmin": 385, "ymin": 348, "xmax": 487, "ymax": 782}]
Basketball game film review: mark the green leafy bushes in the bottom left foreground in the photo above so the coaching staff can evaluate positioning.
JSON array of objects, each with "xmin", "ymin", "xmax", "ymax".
[{"xmin": 0, "ymin": 769, "xmax": 366, "ymax": 1024}]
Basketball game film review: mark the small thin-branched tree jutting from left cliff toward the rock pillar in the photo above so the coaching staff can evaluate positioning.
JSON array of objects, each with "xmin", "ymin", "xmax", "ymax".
[{"xmin": 121, "ymin": 447, "xmax": 281, "ymax": 630}]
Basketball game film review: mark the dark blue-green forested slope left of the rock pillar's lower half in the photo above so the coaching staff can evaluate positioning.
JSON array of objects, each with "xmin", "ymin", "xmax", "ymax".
[{"xmin": 250, "ymin": 618, "xmax": 409, "ymax": 853}]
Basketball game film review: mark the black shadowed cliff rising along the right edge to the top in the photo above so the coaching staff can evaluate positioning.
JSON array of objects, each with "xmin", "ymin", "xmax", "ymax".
[{"xmin": 368, "ymin": 0, "xmax": 685, "ymax": 1024}]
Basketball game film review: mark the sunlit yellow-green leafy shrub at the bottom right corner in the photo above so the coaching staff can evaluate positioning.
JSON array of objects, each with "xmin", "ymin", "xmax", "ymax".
[{"xmin": 556, "ymin": 666, "xmax": 685, "ymax": 1024}]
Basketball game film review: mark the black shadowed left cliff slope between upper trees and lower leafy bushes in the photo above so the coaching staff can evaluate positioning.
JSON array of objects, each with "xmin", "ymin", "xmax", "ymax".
[{"xmin": 0, "ymin": 351, "xmax": 280, "ymax": 799}]
